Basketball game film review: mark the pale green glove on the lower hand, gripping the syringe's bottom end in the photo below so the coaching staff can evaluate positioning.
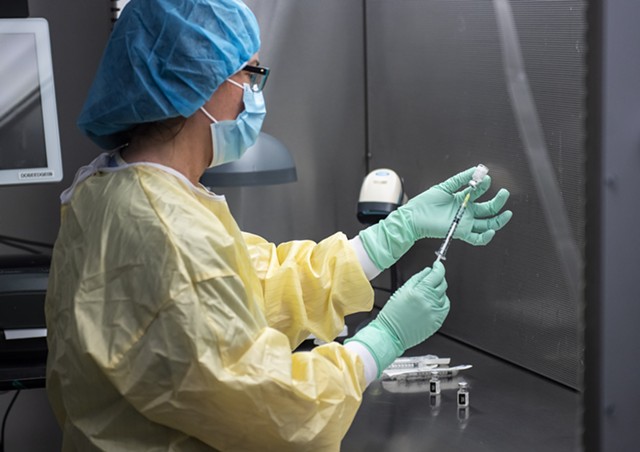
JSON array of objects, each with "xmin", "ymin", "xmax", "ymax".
[{"xmin": 345, "ymin": 261, "xmax": 449, "ymax": 377}]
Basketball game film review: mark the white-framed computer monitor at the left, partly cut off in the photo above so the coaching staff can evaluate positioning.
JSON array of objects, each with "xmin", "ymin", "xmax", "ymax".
[{"xmin": 0, "ymin": 18, "xmax": 62, "ymax": 185}]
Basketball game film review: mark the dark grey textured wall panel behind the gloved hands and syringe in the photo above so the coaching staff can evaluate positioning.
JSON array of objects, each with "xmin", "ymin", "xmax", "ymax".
[{"xmin": 367, "ymin": 0, "xmax": 585, "ymax": 387}]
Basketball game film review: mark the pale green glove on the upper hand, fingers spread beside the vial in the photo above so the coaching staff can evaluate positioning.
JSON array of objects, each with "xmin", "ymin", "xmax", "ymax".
[{"xmin": 359, "ymin": 167, "xmax": 512, "ymax": 270}]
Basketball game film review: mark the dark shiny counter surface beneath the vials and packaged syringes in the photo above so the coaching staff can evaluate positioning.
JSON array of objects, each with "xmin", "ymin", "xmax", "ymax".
[{"xmin": 342, "ymin": 334, "xmax": 581, "ymax": 452}]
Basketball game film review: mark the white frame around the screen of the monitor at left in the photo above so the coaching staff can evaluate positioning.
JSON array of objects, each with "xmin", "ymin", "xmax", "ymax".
[{"xmin": 0, "ymin": 17, "xmax": 62, "ymax": 185}]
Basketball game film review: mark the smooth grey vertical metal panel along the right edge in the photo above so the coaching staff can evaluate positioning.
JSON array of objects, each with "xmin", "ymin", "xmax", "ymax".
[{"xmin": 584, "ymin": 0, "xmax": 640, "ymax": 452}]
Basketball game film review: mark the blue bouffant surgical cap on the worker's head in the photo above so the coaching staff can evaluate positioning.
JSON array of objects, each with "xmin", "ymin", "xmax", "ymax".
[{"xmin": 78, "ymin": 0, "xmax": 260, "ymax": 149}]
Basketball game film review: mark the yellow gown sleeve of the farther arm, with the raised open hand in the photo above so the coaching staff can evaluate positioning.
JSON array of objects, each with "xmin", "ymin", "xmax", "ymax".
[{"xmin": 243, "ymin": 232, "xmax": 373, "ymax": 348}]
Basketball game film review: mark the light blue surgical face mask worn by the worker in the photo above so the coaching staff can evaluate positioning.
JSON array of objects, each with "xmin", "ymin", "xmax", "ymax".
[{"xmin": 200, "ymin": 80, "xmax": 267, "ymax": 168}]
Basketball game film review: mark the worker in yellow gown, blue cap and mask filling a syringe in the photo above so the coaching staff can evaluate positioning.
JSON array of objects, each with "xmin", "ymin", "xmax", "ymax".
[{"xmin": 46, "ymin": 0, "xmax": 511, "ymax": 451}]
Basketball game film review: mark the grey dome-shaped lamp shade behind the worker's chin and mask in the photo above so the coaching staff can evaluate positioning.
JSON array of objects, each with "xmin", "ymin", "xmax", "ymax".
[{"xmin": 200, "ymin": 132, "xmax": 298, "ymax": 187}]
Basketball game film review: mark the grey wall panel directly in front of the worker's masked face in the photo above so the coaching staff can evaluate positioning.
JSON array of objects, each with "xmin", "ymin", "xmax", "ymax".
[{"xmin": 228, "ymin": 0, "xmax": 365, "ymax": 242}]
